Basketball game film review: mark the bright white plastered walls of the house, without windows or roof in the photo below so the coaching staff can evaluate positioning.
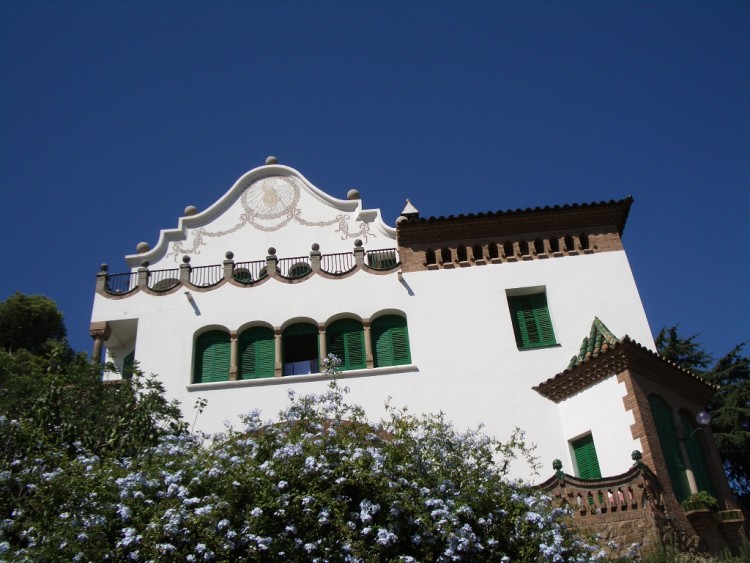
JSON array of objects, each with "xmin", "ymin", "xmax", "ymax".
[{"xmin": 92, "ymin": 164, "xmax": 654, "ymax": 480}]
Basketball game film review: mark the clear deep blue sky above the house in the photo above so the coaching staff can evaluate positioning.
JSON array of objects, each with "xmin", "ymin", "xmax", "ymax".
[{"xmin": 0, "ymin": 0, "xmax": 750, "ymax": 355}]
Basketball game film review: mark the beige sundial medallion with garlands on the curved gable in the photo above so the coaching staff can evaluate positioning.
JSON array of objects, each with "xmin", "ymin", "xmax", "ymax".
[{"xmin": 168, "ymin": 176, "xmax": 377, "ymax": 262}]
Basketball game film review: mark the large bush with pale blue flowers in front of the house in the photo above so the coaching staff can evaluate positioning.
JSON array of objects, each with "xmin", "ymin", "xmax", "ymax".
[{"xmin": 0, "ymin": 378, "xmax": 601, "ymax": 561}]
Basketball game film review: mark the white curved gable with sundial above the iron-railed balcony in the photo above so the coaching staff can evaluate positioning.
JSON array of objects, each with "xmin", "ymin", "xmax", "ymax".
[{"xmin": 125, "ymin": 164, "xmax": 396, "ymax": 268}]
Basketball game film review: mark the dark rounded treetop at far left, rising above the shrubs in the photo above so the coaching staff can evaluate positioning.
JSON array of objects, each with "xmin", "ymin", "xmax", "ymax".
[{"xmin": 0, "ymin": 292, "xmax": 66, "ymax": 354}]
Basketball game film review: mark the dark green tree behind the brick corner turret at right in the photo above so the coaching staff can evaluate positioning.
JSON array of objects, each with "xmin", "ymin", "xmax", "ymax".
[{"xmin": 656, "ymin": 326, "xmax": 750, "ymax": 505}]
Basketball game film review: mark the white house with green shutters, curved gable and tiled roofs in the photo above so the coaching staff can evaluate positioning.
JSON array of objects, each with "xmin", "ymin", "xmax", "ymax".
[{"xmin": 92, "ymin": 158, "xmax": 744, "ymax": 552}]
